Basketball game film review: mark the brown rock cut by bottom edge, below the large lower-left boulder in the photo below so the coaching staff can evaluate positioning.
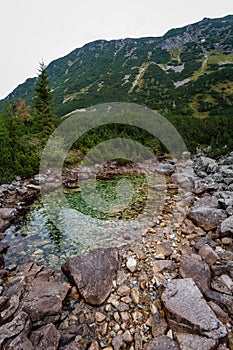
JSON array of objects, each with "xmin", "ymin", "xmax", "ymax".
[{"xmin": 30, "ymin": 324, "xmax": 60, "ymax": 350}]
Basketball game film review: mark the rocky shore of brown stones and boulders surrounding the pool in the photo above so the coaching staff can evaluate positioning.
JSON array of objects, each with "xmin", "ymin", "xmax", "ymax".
[{"xmin": 0, "ymin": 153, "xmax": 233, "ymax": 350}]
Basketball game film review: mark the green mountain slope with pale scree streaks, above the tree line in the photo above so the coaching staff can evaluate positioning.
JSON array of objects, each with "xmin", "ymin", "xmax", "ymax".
[{"xmin": 1, "ymin": 16, "xmax": 233, "ymax": 117}]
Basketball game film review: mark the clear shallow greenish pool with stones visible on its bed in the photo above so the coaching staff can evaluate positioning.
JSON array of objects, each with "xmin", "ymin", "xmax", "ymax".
[{"xmin": 4, "ymin": 175, "xmax": 166, "ymax": 268}]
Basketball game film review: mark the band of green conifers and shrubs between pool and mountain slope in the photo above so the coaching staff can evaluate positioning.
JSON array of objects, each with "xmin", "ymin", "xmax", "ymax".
[{"xmin": 0, "ymin": 62, "xmax": 233, "ymax": 183}]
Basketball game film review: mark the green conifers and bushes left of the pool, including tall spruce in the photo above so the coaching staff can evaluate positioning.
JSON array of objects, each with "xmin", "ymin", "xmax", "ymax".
[{"xmin": 0, "ymin": 62, "xmax": 57, "ymax": 183}]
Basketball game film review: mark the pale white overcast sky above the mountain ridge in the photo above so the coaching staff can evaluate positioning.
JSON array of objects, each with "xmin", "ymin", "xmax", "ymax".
[{"xmin": 0, "ymin": 0, "xmax": 233, "ymax": 98}]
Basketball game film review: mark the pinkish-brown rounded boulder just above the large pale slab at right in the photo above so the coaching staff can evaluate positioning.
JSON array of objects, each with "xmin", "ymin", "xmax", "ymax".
[{"xmin": 179, "ymin": 254, "xmax": 211, "ymax": 292}]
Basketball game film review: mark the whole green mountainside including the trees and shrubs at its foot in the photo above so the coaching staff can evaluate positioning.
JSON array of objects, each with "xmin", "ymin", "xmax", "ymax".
[{"xmin": 0, "ymin": 16, "xmax": 233, "ymax": 182}]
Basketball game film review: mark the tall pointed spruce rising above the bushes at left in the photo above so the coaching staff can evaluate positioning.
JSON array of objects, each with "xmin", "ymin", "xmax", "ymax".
[{"xmin": 33, "ymin": 62, "xmax": 56, "ymax": 139}]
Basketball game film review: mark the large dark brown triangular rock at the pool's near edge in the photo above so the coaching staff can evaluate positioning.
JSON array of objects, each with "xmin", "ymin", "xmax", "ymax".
[{"xmin": 62, "ymin": 248, "xmax": 119, "ymax": 305}]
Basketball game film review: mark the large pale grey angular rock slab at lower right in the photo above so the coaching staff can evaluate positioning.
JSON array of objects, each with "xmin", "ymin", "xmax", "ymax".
[{"xmin": 161, "ymin": 278, "xmax": 227, "ymax": 339}]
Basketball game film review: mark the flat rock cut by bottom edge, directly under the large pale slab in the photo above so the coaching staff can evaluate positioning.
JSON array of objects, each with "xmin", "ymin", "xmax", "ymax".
[{"xmin": 176, "ymin": 333, "xmax": 217, "ymax": 350}]
